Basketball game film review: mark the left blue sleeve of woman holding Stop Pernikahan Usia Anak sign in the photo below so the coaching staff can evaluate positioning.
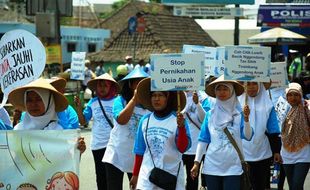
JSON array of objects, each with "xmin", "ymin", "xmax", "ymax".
[{"xmin": 133, "ymin": 114, "xmax": 150, "ymax": 156}]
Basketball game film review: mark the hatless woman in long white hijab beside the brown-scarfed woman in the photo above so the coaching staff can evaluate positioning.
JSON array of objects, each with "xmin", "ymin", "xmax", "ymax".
[{"xmin": 239, "ymin": 82, "xmax": 281, "ymax": 190}]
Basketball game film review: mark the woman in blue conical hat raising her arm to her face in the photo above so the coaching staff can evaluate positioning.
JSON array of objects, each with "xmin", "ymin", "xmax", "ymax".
[{"xmin": 102, "ymin": 68, "xmax": 148, "ymax": 190}]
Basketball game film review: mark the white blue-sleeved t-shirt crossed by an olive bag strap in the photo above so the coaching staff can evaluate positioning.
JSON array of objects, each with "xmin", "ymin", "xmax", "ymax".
[{"xmin": 198, "ymin": 110, "xmax": 248, "ymax": 176}]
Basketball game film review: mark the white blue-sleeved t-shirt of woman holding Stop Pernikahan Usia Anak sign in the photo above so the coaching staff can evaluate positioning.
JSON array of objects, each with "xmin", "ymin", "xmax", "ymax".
[{"xmin": 134, "ymin": 112, "xmax": 191, "ymax": 190}]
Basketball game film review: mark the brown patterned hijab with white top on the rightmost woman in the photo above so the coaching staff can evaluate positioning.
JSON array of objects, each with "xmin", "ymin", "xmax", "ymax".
[{"xmin": 281, "ymin": 83, "xmax": 310, "ymax": 152}]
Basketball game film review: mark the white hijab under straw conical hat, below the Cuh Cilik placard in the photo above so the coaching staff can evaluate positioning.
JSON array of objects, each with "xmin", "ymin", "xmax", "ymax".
[{"xmin": 211, "ymin": 83, "xmax": 240, "ymax": 129}]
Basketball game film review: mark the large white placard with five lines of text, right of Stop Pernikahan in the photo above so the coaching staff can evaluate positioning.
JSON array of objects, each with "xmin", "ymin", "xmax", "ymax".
[{"xmin": 224, "ymin": 46, "xmax": 271, "ymax": 82}]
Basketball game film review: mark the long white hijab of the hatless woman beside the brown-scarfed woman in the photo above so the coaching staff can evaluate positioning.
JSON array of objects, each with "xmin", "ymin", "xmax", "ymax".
[{"xmin": 239, "ymin": 83, "xmax": 273, "ymax": 141}]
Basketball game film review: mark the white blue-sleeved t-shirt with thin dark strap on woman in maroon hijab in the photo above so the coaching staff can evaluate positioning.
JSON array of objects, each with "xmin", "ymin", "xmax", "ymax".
[{"xmin": 83, "ymin": 97, "xmax": 115, "ymax": 150}]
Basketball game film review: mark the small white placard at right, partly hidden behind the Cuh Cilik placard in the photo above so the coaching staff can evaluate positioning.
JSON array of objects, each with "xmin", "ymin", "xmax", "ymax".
[{"xmin": 270, "ymin": 62, "xmax": 289, "ymax": 88}]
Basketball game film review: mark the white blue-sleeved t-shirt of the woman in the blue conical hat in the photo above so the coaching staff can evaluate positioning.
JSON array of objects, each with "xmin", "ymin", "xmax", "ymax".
[{"xmin": 102, "ymin": 96, "xmax": 149, "ymax": 173}]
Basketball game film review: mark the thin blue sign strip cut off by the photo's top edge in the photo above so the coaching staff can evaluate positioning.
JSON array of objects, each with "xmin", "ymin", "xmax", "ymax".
[{"xmin": 161, "ymin": 0, "xmax": 255, "ymax": 5}]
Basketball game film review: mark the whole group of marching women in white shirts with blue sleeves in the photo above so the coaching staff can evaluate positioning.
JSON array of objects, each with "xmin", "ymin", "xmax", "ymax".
[{"xmin": 0, "ymin": 55, "xmax": 310, "ymax": 190}]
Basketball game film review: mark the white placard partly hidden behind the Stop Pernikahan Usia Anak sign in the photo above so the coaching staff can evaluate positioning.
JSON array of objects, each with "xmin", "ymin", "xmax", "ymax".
[{"xmin": 183, "ymin": 45, "xmax": 216, "ymax": 75}]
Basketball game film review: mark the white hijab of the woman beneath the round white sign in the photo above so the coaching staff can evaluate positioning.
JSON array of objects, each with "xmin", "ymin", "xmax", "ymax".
[{"xmin": 18, "ymin": 89, "xmax": 57, "ymax": 130}]
